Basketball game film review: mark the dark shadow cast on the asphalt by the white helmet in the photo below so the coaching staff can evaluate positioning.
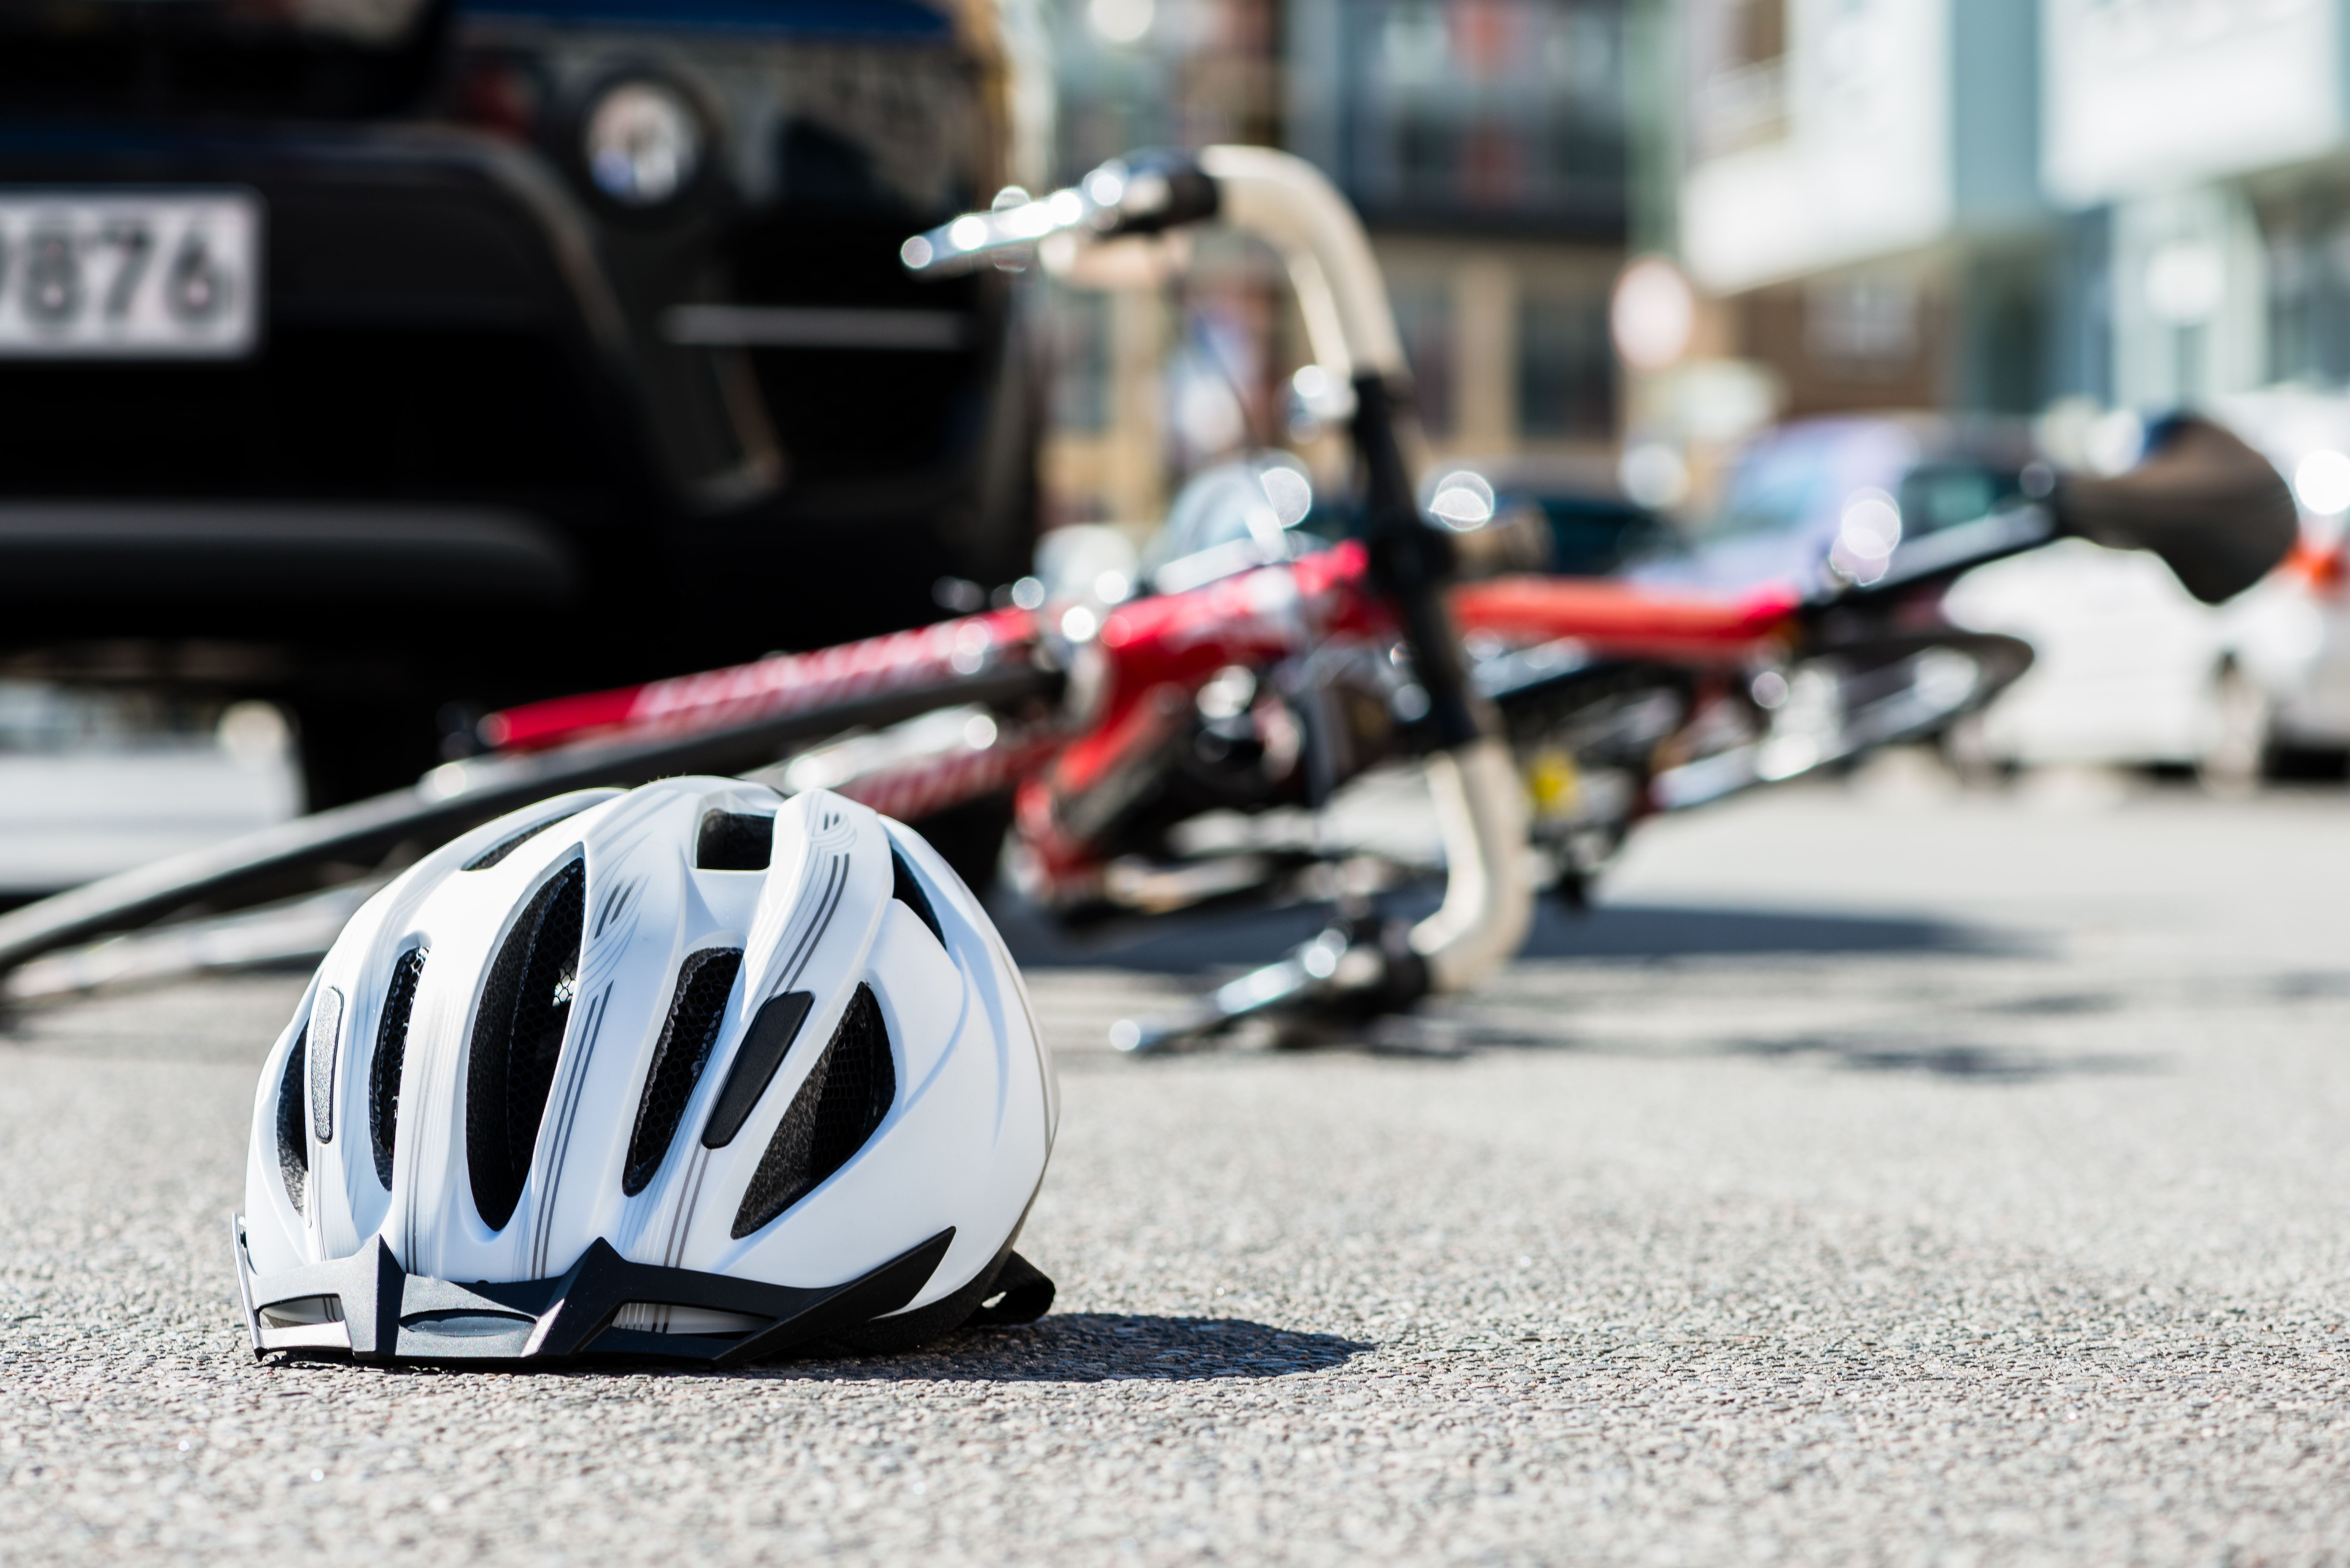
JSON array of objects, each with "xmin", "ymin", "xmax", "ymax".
[{"xmin": 761, "ymin": 1312, "xmax": 1375, "ymax": 1382}]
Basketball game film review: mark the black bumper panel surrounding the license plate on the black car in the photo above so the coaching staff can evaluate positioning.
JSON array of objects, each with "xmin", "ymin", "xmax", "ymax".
[{"xmin": 0, "ymin": 124, "xmax": 658, "ymax": 512}]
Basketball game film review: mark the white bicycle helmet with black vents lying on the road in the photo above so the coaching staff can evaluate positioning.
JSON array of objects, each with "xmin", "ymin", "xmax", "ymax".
[{"xmin": 235, "ymin": 778, "xmax": 1060, "ymax": 1366}]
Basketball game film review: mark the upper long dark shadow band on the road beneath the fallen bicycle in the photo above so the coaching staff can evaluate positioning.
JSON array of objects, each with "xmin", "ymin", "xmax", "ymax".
[{"xmin": 989, "ymin": 889, "xmax": 2031, "ymax": 976}]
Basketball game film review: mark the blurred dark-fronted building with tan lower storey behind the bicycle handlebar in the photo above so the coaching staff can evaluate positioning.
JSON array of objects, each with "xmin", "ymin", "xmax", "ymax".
[{"xmin": 1285, "ymin": 0, "xmax": 1626, "ymax": 465}]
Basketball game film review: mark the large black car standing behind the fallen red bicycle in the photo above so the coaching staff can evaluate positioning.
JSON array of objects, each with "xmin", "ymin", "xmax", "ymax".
[{"xmin": 0, "ymin": 0, "xmax": 1041, "ymax": 806}]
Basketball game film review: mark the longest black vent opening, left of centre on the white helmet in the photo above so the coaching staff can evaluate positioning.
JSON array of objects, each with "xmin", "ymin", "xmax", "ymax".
[{"xmin": 465, "ymin": 860, "xmax": 588, "ymax": 1229}]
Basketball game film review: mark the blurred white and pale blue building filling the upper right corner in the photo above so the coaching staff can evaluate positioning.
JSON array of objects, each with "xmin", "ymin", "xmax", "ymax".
[{"xmin": 1673, "ymin": 0, "xmax": 2350, "ymax": 442}]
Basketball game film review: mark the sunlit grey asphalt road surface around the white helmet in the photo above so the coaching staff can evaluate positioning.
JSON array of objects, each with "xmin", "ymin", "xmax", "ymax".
[{"xmin": 0, "ymin": 778, "xmax": 2350, "ymax": 1563}]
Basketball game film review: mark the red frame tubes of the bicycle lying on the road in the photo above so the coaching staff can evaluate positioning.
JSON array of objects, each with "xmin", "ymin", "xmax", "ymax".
[{"xmin": 482, "ymin": 541, "xmax": 1795, "ymax": 886}]
